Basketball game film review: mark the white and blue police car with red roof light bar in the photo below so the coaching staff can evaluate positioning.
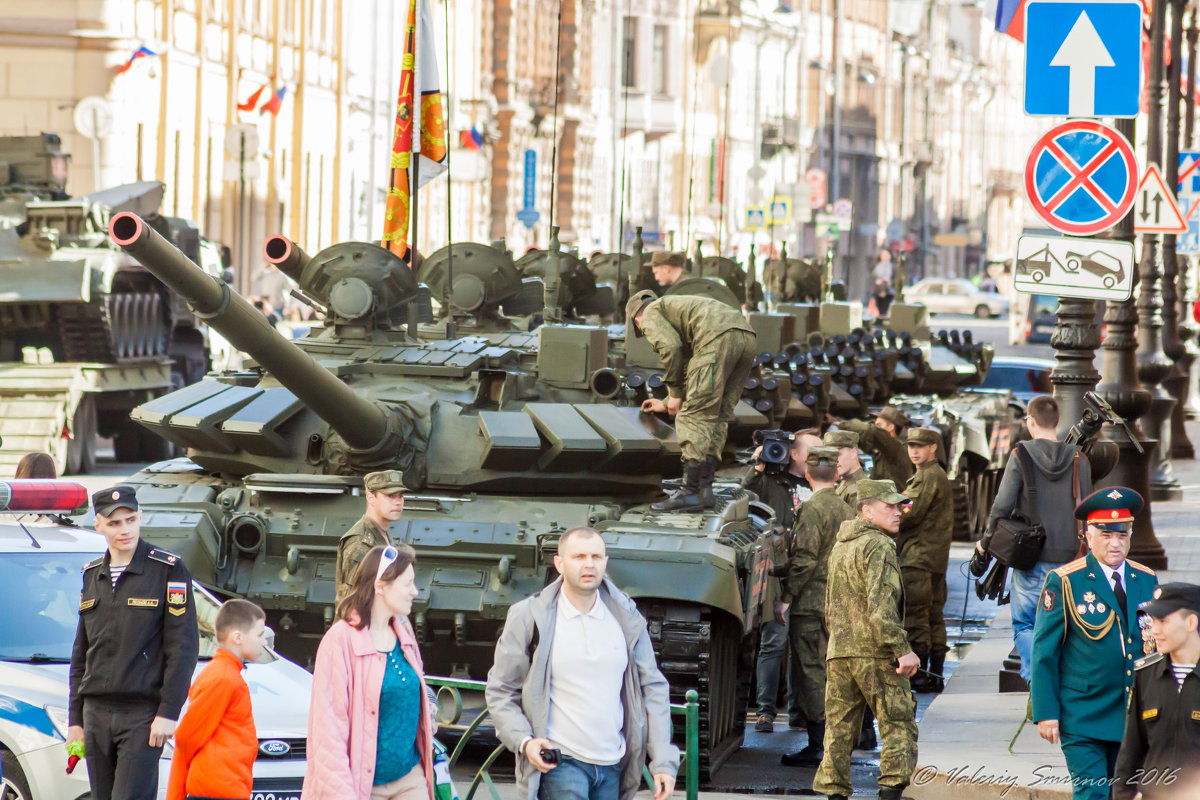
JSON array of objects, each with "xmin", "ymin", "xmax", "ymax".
[{"xmin": 0, "ymin": 481, "xmax": 312, "ymax": 800}]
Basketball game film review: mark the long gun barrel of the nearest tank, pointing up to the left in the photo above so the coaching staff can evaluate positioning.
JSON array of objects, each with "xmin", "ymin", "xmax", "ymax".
[{"xmin": 108, "ymin": 212, "xmax": 389, "ymax": 450}]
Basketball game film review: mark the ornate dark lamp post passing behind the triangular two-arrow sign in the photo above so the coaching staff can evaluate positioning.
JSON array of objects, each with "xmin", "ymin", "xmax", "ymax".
[{"xmin": 1138, "ymin": 2, "xmax": 1182, "ymax": 500}]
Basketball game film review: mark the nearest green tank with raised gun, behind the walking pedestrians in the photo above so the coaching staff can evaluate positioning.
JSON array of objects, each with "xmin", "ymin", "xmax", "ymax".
[{"xmin": 110, "ymin": 213, "xmax": 773, "ymax": 774}]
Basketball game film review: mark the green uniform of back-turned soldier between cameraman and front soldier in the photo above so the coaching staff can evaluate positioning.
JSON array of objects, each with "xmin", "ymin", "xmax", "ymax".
[{"xmin": 784, "ymin": 489, "xmax": 854, "ymax": 722}]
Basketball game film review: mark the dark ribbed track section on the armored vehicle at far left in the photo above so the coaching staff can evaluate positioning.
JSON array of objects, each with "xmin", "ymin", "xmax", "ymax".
[{"xmin": 56, "ymin": 291, "xmax": 170, "ymax": 363}]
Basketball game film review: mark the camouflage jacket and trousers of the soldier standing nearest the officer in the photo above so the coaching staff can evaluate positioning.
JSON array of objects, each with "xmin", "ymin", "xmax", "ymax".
[{"xmin": 812, "ymin": 518, "xmax": 917, "ymax": 796}]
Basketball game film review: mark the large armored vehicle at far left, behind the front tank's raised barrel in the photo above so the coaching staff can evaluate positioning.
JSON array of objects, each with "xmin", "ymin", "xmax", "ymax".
[{"xmin": 0, "ymin": 173, "xmax": 226, "ymax": 474}]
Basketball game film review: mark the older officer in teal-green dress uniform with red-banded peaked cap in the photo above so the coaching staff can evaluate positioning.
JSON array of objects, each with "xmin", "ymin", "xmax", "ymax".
[{"xmin": 1031, "ymin": 487, "xmax": 1158, "ymax": 800}]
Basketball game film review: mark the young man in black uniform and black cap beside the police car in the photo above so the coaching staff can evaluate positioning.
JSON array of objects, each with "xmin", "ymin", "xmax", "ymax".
[{"xmin": 67, "ymin": 486, "xmax": 199, "ymax": 800}]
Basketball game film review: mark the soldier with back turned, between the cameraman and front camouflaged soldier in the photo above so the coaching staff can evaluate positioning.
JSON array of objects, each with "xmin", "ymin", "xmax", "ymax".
[{"xmin": 781, "ymin": 447, "xmax": 854, "ymax": 766}]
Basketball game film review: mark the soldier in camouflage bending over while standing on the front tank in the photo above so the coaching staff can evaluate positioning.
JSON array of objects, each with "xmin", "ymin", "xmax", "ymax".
[{"xmin": 625, "ymin": 290, "xmax": 756, "ymax": 512}]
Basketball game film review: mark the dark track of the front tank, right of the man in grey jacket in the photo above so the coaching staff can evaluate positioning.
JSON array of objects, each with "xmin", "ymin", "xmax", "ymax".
[{"xmin": 638, "ymin": 600, "xmax": 754, "ymax": 782}]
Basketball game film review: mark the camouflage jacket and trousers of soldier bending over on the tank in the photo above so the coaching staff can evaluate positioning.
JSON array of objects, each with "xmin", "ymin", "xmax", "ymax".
[{"xmin": 641, "ymin": 295, "xmax": 756, "ymax": 462}]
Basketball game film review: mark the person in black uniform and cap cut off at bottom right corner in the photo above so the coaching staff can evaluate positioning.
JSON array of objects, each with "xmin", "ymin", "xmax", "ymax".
[{"xmin": 1112, "ymin": 583, "xmax": 1200, "ymax": 800}]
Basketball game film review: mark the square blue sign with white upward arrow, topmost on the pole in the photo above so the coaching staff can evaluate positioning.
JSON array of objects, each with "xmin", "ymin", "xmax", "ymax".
[{"xmin": 1025, "ymin": 0, "xmax": 1141, "ymax": 118}]
